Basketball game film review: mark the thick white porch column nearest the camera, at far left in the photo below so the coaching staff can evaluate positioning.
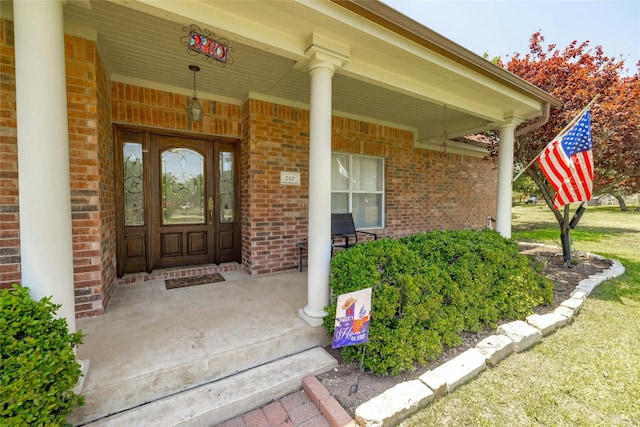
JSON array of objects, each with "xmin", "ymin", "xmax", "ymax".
[{"xmin": 13, "ymin": 0, "xmax": 76, "ymax": 332}]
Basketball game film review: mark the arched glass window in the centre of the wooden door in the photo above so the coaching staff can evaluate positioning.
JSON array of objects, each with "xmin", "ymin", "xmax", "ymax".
[{"xmin": 162, "ymin": 148, "xmax": 206, "ymax": 225}]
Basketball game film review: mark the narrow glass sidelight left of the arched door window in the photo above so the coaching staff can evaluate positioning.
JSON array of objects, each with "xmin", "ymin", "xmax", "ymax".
[{"xmin": 123, "ymin": 142, "xmax": 144, "ymax": 227}]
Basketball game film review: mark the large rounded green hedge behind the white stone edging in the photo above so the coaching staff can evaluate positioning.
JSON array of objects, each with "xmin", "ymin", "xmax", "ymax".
[{"xmin": 324, "ymin": 230, "xmax": 553, "ymax": 375}]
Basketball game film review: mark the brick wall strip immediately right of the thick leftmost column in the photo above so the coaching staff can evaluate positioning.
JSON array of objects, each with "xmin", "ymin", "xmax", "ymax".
[{"xmin": 64, "ymin": 35, "xmax": 110, "ymax": 317}]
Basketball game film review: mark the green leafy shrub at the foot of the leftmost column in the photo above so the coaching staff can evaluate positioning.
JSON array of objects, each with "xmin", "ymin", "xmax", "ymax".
[{"xmin": 0, "ymin": 285, "xmax": 83, "ymax": 426}]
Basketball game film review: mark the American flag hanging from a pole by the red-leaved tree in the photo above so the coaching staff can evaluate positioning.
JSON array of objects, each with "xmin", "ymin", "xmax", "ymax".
[{"xmin": 538, "ymin": 110, "xmax": 593, "ymax": 210}]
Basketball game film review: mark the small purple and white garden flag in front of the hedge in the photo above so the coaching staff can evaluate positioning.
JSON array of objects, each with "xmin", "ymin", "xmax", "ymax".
[{"xmin": 332, "ymin": 288, "xmax": 371, "ymax": 348}]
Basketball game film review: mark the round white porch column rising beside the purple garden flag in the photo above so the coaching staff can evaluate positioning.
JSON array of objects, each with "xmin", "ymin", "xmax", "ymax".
[{"xmin": 300, "ymin": 59, "xmax": 335, "ymax": 325}]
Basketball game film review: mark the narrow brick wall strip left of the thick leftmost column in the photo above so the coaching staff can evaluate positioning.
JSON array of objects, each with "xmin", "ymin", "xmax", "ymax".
[{"xmin": 0, "ymin": 20, "xmax": 20, "ymax": 289}]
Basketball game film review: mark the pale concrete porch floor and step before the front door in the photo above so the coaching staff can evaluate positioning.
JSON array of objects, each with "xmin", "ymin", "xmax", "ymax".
[{"xmin": 67, "ymin": 271, "xmax": 337, "ymax": 427}]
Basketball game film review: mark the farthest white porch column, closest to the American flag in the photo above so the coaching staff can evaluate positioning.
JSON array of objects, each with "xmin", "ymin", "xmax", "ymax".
[{"xmin": 496, "ymin": 121, "xmax": 518, "ymax": 238}]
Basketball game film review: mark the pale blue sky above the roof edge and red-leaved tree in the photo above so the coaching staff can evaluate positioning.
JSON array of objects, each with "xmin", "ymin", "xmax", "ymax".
[{"xmin": 381, "ymin": 0, "xmax": 640, "ymax": 74}]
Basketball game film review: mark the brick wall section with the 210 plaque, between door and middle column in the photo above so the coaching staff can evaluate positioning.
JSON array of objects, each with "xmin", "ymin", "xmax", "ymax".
[{"xmin": 241, "ymin": 99, "xmax": 309, "ymax": 274}]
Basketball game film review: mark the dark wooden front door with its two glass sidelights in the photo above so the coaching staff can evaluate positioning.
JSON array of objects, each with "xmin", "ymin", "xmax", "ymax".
[{"xmin": 114, "ymin": 127, "xmax": 240, "ymax": 276}]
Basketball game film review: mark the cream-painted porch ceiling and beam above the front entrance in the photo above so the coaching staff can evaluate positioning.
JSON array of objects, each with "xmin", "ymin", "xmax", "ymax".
[{"xmin": 51, "ymin": 0, "xmax": 556, "ymax": 147}]
